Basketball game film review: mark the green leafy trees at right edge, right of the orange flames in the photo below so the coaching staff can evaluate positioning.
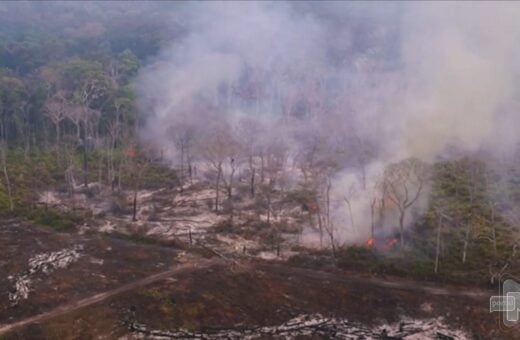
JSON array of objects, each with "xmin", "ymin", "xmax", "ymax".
[{"xmin": 407, "ymin": 157, "xmax": 520, "ymax": 283}]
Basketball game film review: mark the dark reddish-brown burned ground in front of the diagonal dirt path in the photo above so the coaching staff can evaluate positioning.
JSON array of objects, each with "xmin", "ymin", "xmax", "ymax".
[{"xmin": 2, "ymin": 254, "xmax": 516, "ymax": 339}]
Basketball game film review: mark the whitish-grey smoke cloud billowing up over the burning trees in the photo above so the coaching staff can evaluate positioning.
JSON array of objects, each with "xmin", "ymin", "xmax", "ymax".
[{"xmin": 138, "ymin": 2, "xmax": 520, "ymax": 244}]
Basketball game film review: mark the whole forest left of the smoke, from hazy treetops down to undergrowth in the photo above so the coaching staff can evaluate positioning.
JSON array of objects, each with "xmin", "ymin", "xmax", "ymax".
[{"xmin": 0, "ymin": 1, "xmax": 183, "ymax": 223}]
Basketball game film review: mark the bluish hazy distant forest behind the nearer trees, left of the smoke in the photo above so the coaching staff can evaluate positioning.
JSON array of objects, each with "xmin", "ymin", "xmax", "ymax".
[{"xmin": 0, "ymin": 2, "xmax": 174, "ymax": 75}]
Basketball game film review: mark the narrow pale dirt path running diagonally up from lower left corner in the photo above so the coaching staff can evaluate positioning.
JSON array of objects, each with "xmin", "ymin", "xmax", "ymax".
[{"xmin": 0, "ymin": 259, "xmax": 219, "ymax": 335}]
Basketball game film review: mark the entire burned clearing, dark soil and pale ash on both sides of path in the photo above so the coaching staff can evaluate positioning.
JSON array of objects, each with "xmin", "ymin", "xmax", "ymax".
[{"xmin": 0, "ymin": 185, "xmax": 517, "ymax": 339}]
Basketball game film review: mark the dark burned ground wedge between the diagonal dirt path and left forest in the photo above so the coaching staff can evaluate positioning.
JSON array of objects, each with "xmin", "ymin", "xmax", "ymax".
[{"xmin": 0, "ymin": 221, "xmax": 176, "ymax": 323}]
